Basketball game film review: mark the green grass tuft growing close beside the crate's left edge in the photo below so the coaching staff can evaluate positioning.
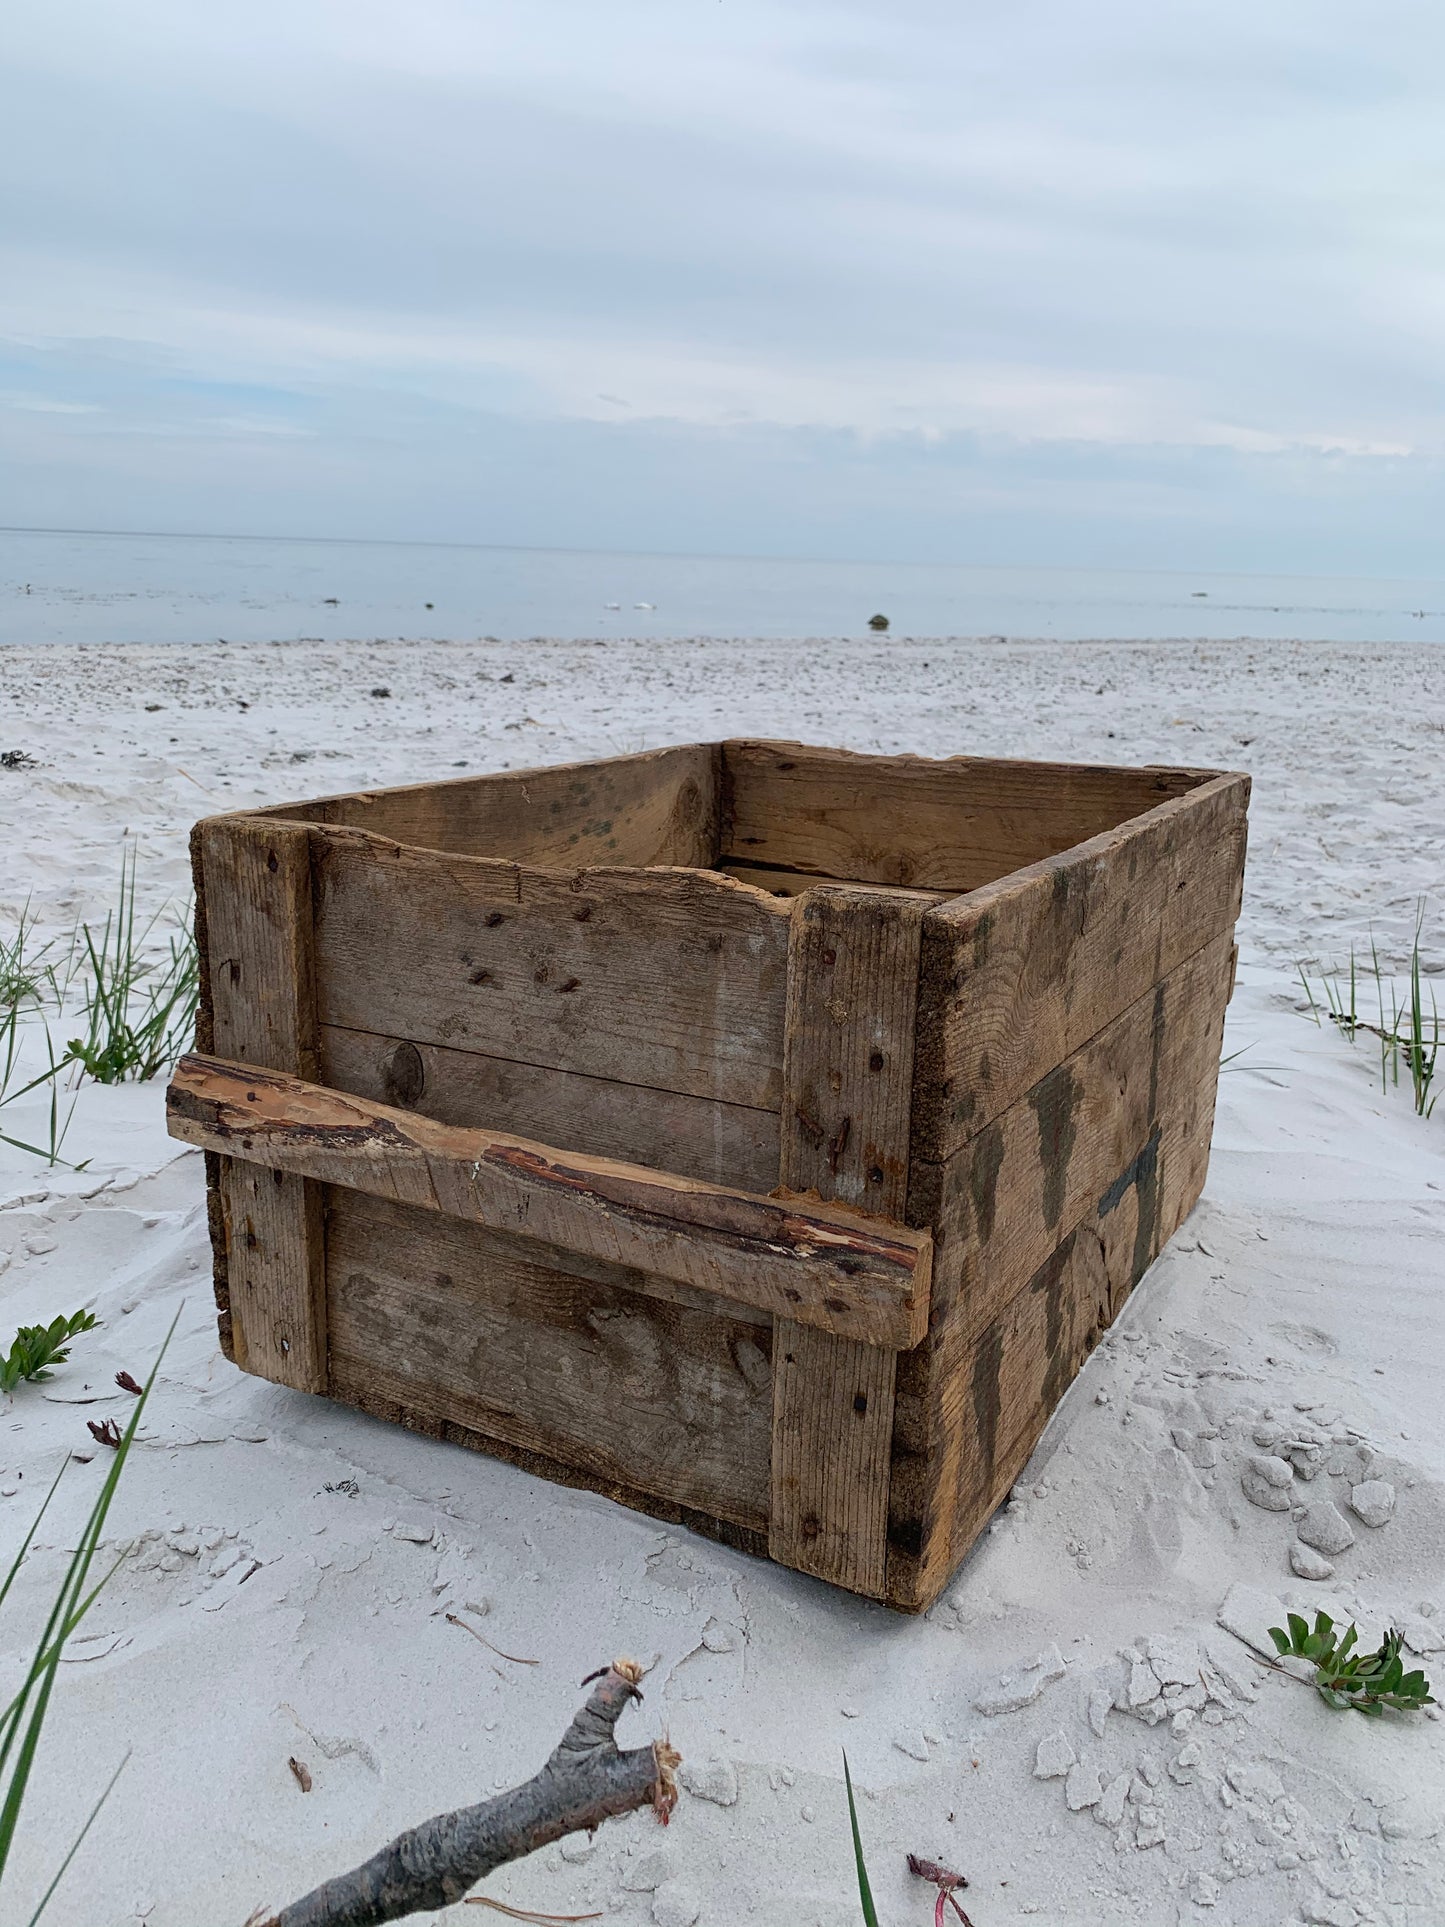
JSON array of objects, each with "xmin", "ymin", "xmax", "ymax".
[{"xmin": 69, "ymin": 850, "xmax": 200, "ymax": 1083}]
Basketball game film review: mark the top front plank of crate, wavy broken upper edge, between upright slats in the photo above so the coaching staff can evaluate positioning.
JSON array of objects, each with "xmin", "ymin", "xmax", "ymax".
[{"xmin": 312, "ymin": 829, "xmax": 788, "ymax": 1110}]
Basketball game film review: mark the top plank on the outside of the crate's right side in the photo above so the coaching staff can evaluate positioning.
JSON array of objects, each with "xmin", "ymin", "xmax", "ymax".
[{"xmin": 913, "ymin": 777, "xmax": 1248, "ymax": 1158}]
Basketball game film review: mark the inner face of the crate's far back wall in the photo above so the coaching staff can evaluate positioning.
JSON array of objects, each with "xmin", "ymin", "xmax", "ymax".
[{"xmin": 723, "ymin": 742, "xmax": 1214, "ymax": 892}]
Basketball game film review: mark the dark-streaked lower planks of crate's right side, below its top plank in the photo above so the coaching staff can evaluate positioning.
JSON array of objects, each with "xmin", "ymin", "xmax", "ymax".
[{"xmin": 888, "ymin": 931, "xmax": 1233, "ymax": 1611}]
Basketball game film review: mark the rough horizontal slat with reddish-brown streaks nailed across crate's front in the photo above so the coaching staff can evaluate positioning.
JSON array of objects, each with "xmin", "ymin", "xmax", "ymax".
[{"xmin": 168, "ymin": 1056, "xmax": 933, "ymax": 1347}]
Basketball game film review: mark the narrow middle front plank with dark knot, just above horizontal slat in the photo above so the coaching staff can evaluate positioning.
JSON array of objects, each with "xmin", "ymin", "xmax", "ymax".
[{"xmin": 318, "ymin": 1023, "xmax": 778, "ymax": 1191}]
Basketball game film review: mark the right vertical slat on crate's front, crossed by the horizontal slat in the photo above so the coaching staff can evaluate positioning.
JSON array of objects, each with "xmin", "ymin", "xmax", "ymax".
[{"xmin": 769, "ymin": 890, "xmax": 927, "ymax": 1597}]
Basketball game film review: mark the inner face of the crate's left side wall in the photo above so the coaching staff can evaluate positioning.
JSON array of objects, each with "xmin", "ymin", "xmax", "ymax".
[{"xmin": 266, "ymin": 744, "xmax": 719, "ymax": 871}]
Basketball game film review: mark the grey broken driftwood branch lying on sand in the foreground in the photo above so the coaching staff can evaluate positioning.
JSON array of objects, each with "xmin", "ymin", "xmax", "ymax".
[{"xmin": 258, "ymin": 1659, "xmax": 678, "ymax": 1927}]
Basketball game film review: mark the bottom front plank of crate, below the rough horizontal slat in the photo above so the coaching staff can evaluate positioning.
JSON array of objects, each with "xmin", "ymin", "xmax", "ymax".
[{"xmin": 328, "ymin": 1191, "xmax": 771, "ymax": 1530}]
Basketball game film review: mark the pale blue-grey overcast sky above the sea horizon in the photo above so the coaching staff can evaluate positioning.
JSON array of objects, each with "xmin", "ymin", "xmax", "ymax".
[{"xmin": 0, "ymin": 0, "xmax": 1445, "ymax": 574}]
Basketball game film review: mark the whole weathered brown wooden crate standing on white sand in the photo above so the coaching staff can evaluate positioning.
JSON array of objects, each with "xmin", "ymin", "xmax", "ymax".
[{"xmin": 170, "ymin": 742, "xmax": 1248, "ymax": 1611}]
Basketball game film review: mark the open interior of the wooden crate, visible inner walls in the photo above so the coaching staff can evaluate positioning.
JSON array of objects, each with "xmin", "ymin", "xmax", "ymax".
[{"xmin": 268, "ymin": 740, "xmax": 1208, "ymax": 896}]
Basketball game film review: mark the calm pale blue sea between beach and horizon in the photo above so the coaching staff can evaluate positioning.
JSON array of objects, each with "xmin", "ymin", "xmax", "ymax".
[{"xmin": 0, "ymin": 530, "xmax": 1445, "ymax": 644}]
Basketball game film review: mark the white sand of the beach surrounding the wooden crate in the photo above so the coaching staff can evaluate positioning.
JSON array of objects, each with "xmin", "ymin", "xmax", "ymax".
[{"xmin": 0, "ymin": 642, "xmax": 1445, "ymax": 1927}]
